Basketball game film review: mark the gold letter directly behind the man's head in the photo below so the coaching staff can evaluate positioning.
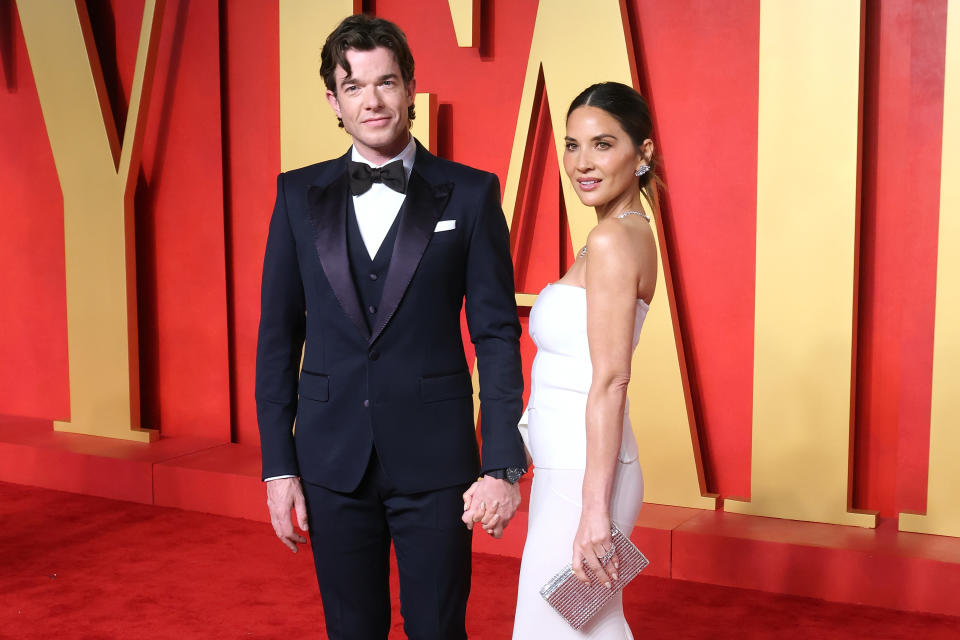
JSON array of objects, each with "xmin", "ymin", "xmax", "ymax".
[{"xmin": 280, "ymin": 0, "xmax": 436, "ymax": 171}]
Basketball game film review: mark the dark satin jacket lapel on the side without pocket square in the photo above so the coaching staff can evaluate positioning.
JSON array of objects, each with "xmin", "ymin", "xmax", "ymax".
[{"xmin": 307, "ymin": 171, "xmax": 370, "ymax": 338}]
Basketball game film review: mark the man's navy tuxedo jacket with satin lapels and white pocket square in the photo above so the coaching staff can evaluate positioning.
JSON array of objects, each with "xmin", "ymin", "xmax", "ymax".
[{"xmin": 256, "ymin": 143, "xmax": 525, "ymax": 493}]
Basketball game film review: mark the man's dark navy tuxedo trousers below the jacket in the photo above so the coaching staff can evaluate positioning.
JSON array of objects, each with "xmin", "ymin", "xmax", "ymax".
[{"xmin": 303, "ymin": 452, "xmax": 472, "ymax": 640}]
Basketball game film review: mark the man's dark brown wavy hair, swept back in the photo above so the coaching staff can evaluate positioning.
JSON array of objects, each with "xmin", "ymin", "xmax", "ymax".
[{"xmin": 320, "ymin": 14, "xmax": 415, "ymax": 127}]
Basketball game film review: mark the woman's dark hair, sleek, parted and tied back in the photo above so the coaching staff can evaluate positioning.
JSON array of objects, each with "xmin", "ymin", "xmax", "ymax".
[{"xmin": 567, "ymin": 82, "xmax": 662, "ymax": 203}]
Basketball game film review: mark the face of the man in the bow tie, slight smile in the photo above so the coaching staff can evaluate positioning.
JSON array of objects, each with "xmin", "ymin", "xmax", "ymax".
[{"xmin": 327, "ymin": 47, "xmax": 417, "ymax": 164}]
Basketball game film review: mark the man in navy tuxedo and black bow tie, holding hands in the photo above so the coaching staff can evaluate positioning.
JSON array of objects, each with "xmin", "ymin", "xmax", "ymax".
[{"xmin": 256, "ymin": 15, "xmax": 526, "ymax": 640}]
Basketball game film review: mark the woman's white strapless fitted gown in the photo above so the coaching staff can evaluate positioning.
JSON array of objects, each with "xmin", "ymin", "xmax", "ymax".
[{"xmin": 513, "ymin": 283, "xmax": 649, "ymax": 640}]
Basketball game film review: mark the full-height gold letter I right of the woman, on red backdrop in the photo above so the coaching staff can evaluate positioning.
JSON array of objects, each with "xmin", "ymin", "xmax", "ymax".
[{"xmin": 725, "ymin": 0, "xmax": 876, "ymax": 527}]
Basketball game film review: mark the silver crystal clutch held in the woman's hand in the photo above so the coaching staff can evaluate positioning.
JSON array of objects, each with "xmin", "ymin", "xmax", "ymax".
[{"xmin": 540, "ymin": 526, "xmax": 650, "ymax": 629}]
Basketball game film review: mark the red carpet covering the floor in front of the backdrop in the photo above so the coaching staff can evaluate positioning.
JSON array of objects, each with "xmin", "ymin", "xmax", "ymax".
[{"xmin": 0, "ymin": 483, "xmax": 960, "ymax": 640}]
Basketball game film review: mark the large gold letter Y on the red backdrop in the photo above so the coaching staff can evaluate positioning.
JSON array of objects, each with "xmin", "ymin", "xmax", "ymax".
[{"xmin": 17, "ymin": 0, "xmax": 163, "ymax": 442}]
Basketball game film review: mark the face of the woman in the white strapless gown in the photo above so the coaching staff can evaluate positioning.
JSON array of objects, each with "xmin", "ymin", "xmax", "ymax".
[{"xmin": 563, "ymin": 106, "xmax": 646, "ymax": 207}]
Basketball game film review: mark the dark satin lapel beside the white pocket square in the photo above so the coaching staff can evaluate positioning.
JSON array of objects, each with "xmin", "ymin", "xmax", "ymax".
[{"xmin": 370, "ymin": 168, "xmax": 453, "ymax": 344}]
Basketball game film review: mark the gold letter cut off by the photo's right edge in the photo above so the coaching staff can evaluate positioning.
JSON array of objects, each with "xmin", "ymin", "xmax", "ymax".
[{"xmin": 900, "ymin": 0, "xmax": 960, "ymax": 536}]
